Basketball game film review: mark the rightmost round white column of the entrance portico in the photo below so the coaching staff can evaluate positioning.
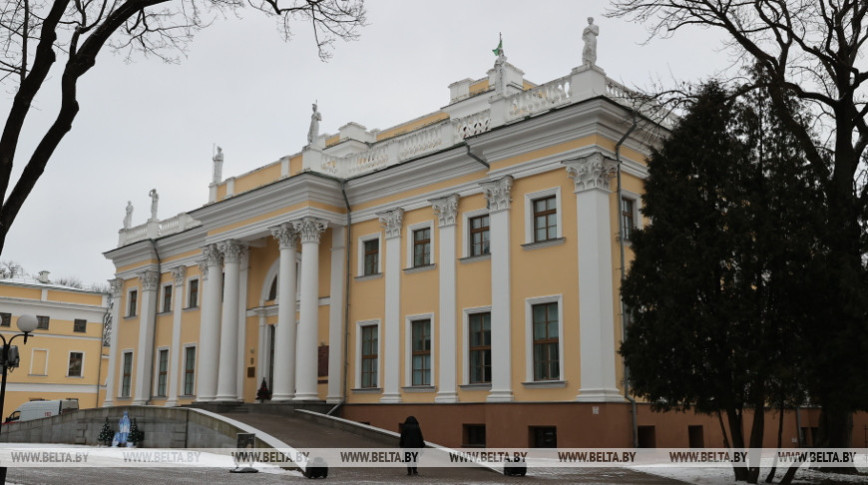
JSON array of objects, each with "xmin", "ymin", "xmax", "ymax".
[{"xmin": 293, "ymin": 217, "xmax": 328, "ymax": 401}]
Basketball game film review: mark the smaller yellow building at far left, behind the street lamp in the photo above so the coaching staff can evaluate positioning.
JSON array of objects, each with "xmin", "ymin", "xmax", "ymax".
[{"xmin": 0, "ymin": 278, "xmax": 109, "ymax": 418}]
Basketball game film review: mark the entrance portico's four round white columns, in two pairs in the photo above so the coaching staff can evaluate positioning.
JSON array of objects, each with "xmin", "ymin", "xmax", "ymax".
[{"xmin": 189, "ymin": 217, "xmax": 328, "ymax": 401}]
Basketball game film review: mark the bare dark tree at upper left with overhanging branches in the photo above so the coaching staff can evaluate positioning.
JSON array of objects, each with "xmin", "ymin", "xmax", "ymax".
[{"xmin": 0, "ymin": 0, "xmax": 365, "ymax": 253}]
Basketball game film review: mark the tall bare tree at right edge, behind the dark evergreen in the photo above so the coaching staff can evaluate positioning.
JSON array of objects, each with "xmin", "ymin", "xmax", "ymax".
[{"xmin": 609, "ymin": 0, "xmax": 868, "ymax": 447}]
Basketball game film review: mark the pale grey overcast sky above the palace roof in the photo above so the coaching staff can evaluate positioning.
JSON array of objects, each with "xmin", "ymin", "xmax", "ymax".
[{"xmin": 0, "ymin": 0, "xmax": 729, "ymax": 284}]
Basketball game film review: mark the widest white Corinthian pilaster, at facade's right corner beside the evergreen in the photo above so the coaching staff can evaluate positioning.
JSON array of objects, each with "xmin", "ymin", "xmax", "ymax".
[{"xmin": 564, "ymin": 153, "xmax": 624, "ymax": 402}]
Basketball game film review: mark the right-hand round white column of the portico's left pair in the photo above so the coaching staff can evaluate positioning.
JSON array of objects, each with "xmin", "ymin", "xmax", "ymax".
[{"xmin": 214, "ymin": 240, "xmax": 242, "ymax": 401}]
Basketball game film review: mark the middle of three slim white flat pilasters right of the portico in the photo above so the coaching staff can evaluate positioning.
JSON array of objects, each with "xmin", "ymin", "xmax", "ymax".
[{"xmin": 431, "ymin": 195, "xmax": 458, "ymax": 402}]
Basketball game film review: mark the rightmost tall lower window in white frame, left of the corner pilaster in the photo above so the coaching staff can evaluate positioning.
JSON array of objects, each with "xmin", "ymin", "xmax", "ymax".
[{"xmin": 525, "ymin": 295, "xmax": 564, "ymax": 382}]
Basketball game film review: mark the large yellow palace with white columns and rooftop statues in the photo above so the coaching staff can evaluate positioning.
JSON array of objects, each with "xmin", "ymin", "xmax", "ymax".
[{"xmin": 105, "ymin": 47, "xmax": 752, "ymax": 447}]
